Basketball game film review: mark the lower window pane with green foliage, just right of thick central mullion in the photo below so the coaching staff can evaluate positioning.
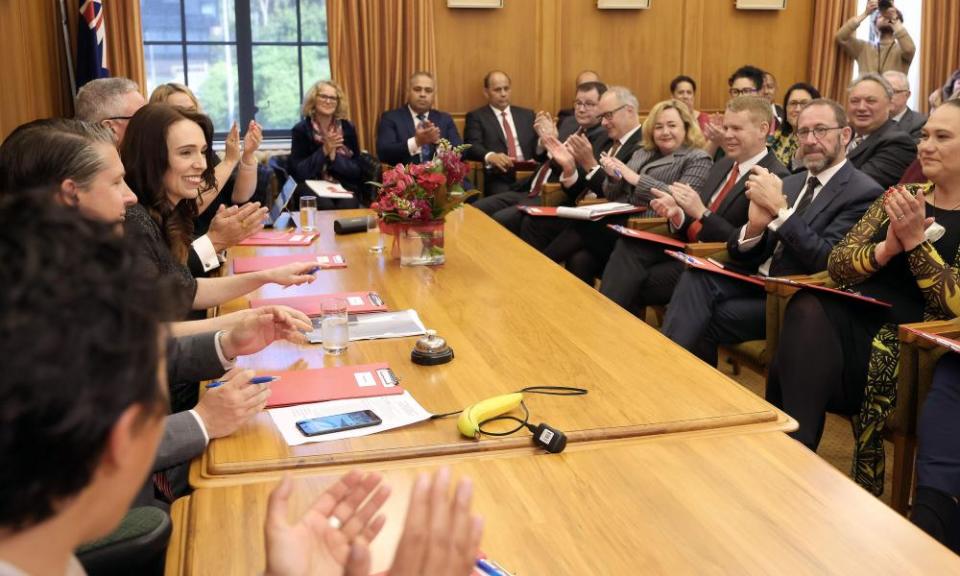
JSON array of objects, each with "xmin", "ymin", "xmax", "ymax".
[{"xmin": 253, "ymin": 46, "xmax": 300, "ymax": 130}]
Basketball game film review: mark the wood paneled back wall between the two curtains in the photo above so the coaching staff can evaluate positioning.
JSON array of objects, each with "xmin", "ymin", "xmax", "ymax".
[{"xmin": 436, "ymin": 0, "xmax": 813, "ymax": 112}]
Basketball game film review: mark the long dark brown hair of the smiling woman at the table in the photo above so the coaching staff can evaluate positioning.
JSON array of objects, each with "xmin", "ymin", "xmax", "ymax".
[{"xmin": 120, "ymin": 104, "xmax": 217, "ymax": 262}]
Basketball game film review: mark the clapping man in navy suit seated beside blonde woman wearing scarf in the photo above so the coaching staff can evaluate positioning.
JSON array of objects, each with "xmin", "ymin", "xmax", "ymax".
[{"xmin": 377, "ymin": 72, "xmax": 463, "ymax": 164}]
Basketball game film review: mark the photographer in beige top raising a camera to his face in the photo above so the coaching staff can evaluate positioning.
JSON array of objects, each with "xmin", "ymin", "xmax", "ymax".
[{"xmin": 834, "ymin": 0, "xmax": 917, "ymax": 74}]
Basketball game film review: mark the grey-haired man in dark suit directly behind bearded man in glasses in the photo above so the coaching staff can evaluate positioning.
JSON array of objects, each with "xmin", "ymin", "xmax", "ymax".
[{"xmin": 847, "ymin": 74, "xmax": 917, "ymax": 188}]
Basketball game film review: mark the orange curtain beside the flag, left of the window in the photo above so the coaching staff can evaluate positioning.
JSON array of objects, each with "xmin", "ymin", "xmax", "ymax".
[{"xmin": 64, "ymin": 0, "xmax": 147, "ymax": 92}]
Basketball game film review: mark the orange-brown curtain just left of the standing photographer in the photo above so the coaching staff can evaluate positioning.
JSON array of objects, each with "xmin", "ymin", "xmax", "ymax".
[{"xmin": 809, "ymin": 0, "xmax": 856, "ymax": 102}]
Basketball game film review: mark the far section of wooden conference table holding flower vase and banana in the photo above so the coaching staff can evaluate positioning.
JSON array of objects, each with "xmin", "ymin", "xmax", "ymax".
[{"xmin": 191, "ymin": 207, "xmax": 796, "ymax": 487}]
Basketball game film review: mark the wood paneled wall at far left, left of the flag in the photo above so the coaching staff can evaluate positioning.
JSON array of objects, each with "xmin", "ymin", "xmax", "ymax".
[{"xmin": 0, "ymin": 0, "xmax": 73, "ymax": 140}]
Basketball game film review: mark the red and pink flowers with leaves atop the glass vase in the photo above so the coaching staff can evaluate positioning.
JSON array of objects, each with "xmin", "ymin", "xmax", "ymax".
[{"xmin": 370, "ymin": 140, "xmax": 477, "ymax": 223}]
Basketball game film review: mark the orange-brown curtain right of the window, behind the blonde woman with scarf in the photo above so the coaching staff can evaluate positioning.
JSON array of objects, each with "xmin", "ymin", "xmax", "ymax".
[{"xmin": 328, "ymin": 0, "xmax": 442, "ymax": 148}]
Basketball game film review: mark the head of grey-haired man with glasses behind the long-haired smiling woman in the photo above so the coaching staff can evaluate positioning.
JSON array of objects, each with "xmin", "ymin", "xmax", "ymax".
[{"xmin": 76, "ymin": 78, "xmax": 147, "ymax": 145}]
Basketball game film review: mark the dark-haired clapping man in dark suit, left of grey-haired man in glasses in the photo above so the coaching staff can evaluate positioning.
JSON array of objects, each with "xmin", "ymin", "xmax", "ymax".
[{"xmin": 474, "ymin": 82, "xmax": 608, "ymax": 235}]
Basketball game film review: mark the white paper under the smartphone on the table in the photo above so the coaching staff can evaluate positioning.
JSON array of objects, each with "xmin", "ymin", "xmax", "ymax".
[{"xmin": 267, "ymin": 391, "xmax": 431, "ymax": 446}]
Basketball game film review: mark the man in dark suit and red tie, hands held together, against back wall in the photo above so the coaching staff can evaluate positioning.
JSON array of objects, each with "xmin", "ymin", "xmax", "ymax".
[{"xmin": 463, "ymin": 70, "xmax": 537, "ymax": 196}]
